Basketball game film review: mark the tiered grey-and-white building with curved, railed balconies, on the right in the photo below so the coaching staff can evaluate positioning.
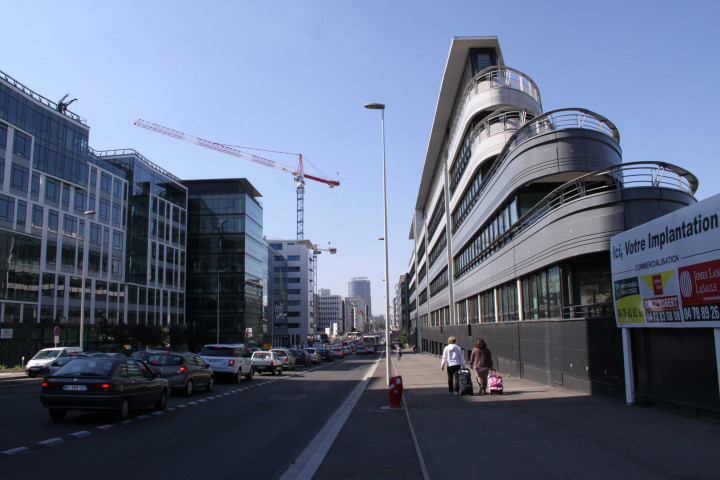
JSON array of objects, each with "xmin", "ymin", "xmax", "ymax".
[{"xmin": 408, "ymin": 37, "xmax": 698, "ymax": 394}]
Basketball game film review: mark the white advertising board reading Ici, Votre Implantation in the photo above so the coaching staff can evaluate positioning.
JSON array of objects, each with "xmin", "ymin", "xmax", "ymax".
[{"xmin": 610, "ymin": 195, "xmax": 720, "ymax": 328}]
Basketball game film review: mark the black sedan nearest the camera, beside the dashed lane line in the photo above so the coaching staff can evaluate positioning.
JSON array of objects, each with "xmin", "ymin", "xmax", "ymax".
[{"xmin": 40, "ymin": 357, "xmax": 170, "ymax": 421}]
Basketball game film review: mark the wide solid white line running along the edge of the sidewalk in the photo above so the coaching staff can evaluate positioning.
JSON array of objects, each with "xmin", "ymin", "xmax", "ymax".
[{"xmin": 280, "ymin": 359, "xmax": 380, "ymax": 480}]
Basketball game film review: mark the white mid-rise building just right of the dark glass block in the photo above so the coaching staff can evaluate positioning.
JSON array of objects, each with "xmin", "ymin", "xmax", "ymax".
[{"xmin": 266, "ymin": 239, "xmax": 315, "ymax": 345}]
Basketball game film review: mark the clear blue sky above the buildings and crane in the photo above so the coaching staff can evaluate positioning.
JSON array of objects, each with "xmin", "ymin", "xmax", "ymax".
[{"xmin": 0, "ymin": 0, "xmax": 720, "ymax": 313}]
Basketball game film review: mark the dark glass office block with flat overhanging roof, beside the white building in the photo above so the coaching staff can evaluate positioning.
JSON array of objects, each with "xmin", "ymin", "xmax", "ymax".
[{"xmin": 184, "ymin": 178, "xmax": 268, "ymax": 349}]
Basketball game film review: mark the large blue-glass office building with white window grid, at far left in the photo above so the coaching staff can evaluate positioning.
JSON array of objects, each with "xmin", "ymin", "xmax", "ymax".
[{"xmin": 0, "ymin": 72, "xmax": 187, "ymax": 359}]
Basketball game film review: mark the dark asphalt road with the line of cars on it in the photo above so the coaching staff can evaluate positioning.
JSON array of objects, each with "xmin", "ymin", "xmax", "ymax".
[{"xmin": 0, "ymin": 355, "xmax": 376, "ymax": 480}]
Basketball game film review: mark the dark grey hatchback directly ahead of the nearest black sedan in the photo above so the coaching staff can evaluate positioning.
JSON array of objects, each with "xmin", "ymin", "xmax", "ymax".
[{"xmin": 147, "ymin": 352, "xmax": 215, "ymax": 397}]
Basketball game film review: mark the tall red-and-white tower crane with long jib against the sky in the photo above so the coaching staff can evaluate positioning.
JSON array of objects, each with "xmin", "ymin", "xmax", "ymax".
[{"xmin": 135, "ymin": 120, "xmax": 340, "ymax": 239}]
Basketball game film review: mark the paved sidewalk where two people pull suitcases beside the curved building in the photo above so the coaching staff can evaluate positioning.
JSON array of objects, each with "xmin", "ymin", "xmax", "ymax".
[{"xmin": 313, "ymin": 353, "xmax": 720, "ymax": 480}]
